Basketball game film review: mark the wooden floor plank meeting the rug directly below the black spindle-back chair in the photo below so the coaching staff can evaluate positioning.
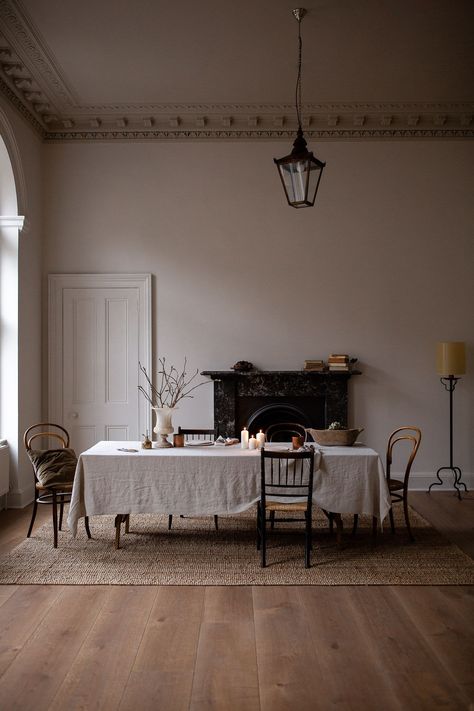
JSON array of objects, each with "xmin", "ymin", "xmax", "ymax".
[{"xmin": 253, "ymin": 586, "xmax": 333, "ymax": 711}]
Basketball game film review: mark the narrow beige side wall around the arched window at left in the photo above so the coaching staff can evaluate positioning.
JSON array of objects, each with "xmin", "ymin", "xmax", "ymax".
[{"xmin": 0, "ymin": 95, "xmax": 43, "ymax": 507}]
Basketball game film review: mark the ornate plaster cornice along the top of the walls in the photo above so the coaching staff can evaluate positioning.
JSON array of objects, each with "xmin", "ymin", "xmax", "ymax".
[{"xmin": 0, "ymin": 0, "xmax": 474, "ymax": 142}]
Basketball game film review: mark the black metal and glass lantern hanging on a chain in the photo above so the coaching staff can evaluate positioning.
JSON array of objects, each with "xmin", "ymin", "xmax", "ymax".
[{"xmin": 273, "ymin": 7, "xmax": 326, "ymax": 207}]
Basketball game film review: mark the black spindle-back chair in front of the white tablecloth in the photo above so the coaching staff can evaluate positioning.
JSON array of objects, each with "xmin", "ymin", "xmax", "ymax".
[{"xmin": 257, "ymin": 448, "xmax": 314, "ymax": 568}]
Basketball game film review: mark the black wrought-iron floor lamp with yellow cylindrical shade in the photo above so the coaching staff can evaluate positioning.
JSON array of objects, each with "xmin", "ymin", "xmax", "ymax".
[{"xmin": 428, "ymin": 341, "xmax": 467, "ymax": 499}]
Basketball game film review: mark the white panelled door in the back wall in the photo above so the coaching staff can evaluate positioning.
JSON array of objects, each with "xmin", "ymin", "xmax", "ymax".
[{"xmin": 50, "ymin": 275, "xmax": 150, "ymax": 453}]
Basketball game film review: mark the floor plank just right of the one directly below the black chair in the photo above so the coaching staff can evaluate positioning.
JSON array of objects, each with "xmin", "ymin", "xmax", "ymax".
[{"xmin": 296, "ymin": 586, "xmax": 400, "ymax": 711}]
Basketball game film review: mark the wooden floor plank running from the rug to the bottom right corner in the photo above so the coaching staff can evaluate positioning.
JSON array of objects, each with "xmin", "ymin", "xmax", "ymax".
[{"xmin": 353, "ymin": 586, "xmax": 469, "ymax": 711}]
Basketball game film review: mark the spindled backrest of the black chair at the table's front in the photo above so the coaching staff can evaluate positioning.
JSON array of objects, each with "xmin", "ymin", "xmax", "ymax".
[{"xmin": 261, "ymin": 448, "xmax": 314, "ymax": 510}]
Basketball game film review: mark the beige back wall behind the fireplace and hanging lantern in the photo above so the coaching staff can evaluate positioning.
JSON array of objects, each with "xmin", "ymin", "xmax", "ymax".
[{"xmin": 43, "ymin": 140, "xmax": 474, "ymax": 486}]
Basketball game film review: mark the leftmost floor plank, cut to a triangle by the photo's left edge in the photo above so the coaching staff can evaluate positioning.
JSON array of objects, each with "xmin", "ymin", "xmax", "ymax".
[{"xmin": 0, "ymin": 585, "xmax": 61, "ymax": 683}]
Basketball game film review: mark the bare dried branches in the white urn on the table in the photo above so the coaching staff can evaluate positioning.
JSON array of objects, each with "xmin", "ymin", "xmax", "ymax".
[{"xmin": 138, "ymin": 358, "xmax": 208, "ymax": 407}]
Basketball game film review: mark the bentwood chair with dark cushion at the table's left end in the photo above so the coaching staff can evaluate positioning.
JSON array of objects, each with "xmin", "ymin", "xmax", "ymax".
[{"xmin": 23, "ymin": 422, "xmax": 91, "ymax": 548}]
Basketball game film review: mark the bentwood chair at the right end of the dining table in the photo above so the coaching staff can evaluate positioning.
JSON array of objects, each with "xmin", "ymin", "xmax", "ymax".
[{"xmin": 352, "ymin": 427, "xmax": 421, "ymax": 541}]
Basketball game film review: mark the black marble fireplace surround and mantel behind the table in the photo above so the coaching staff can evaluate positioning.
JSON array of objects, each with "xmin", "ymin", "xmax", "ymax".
[{"xmin": 201, "ymin": 370, "xmax": 360, "ymax": 437}]
